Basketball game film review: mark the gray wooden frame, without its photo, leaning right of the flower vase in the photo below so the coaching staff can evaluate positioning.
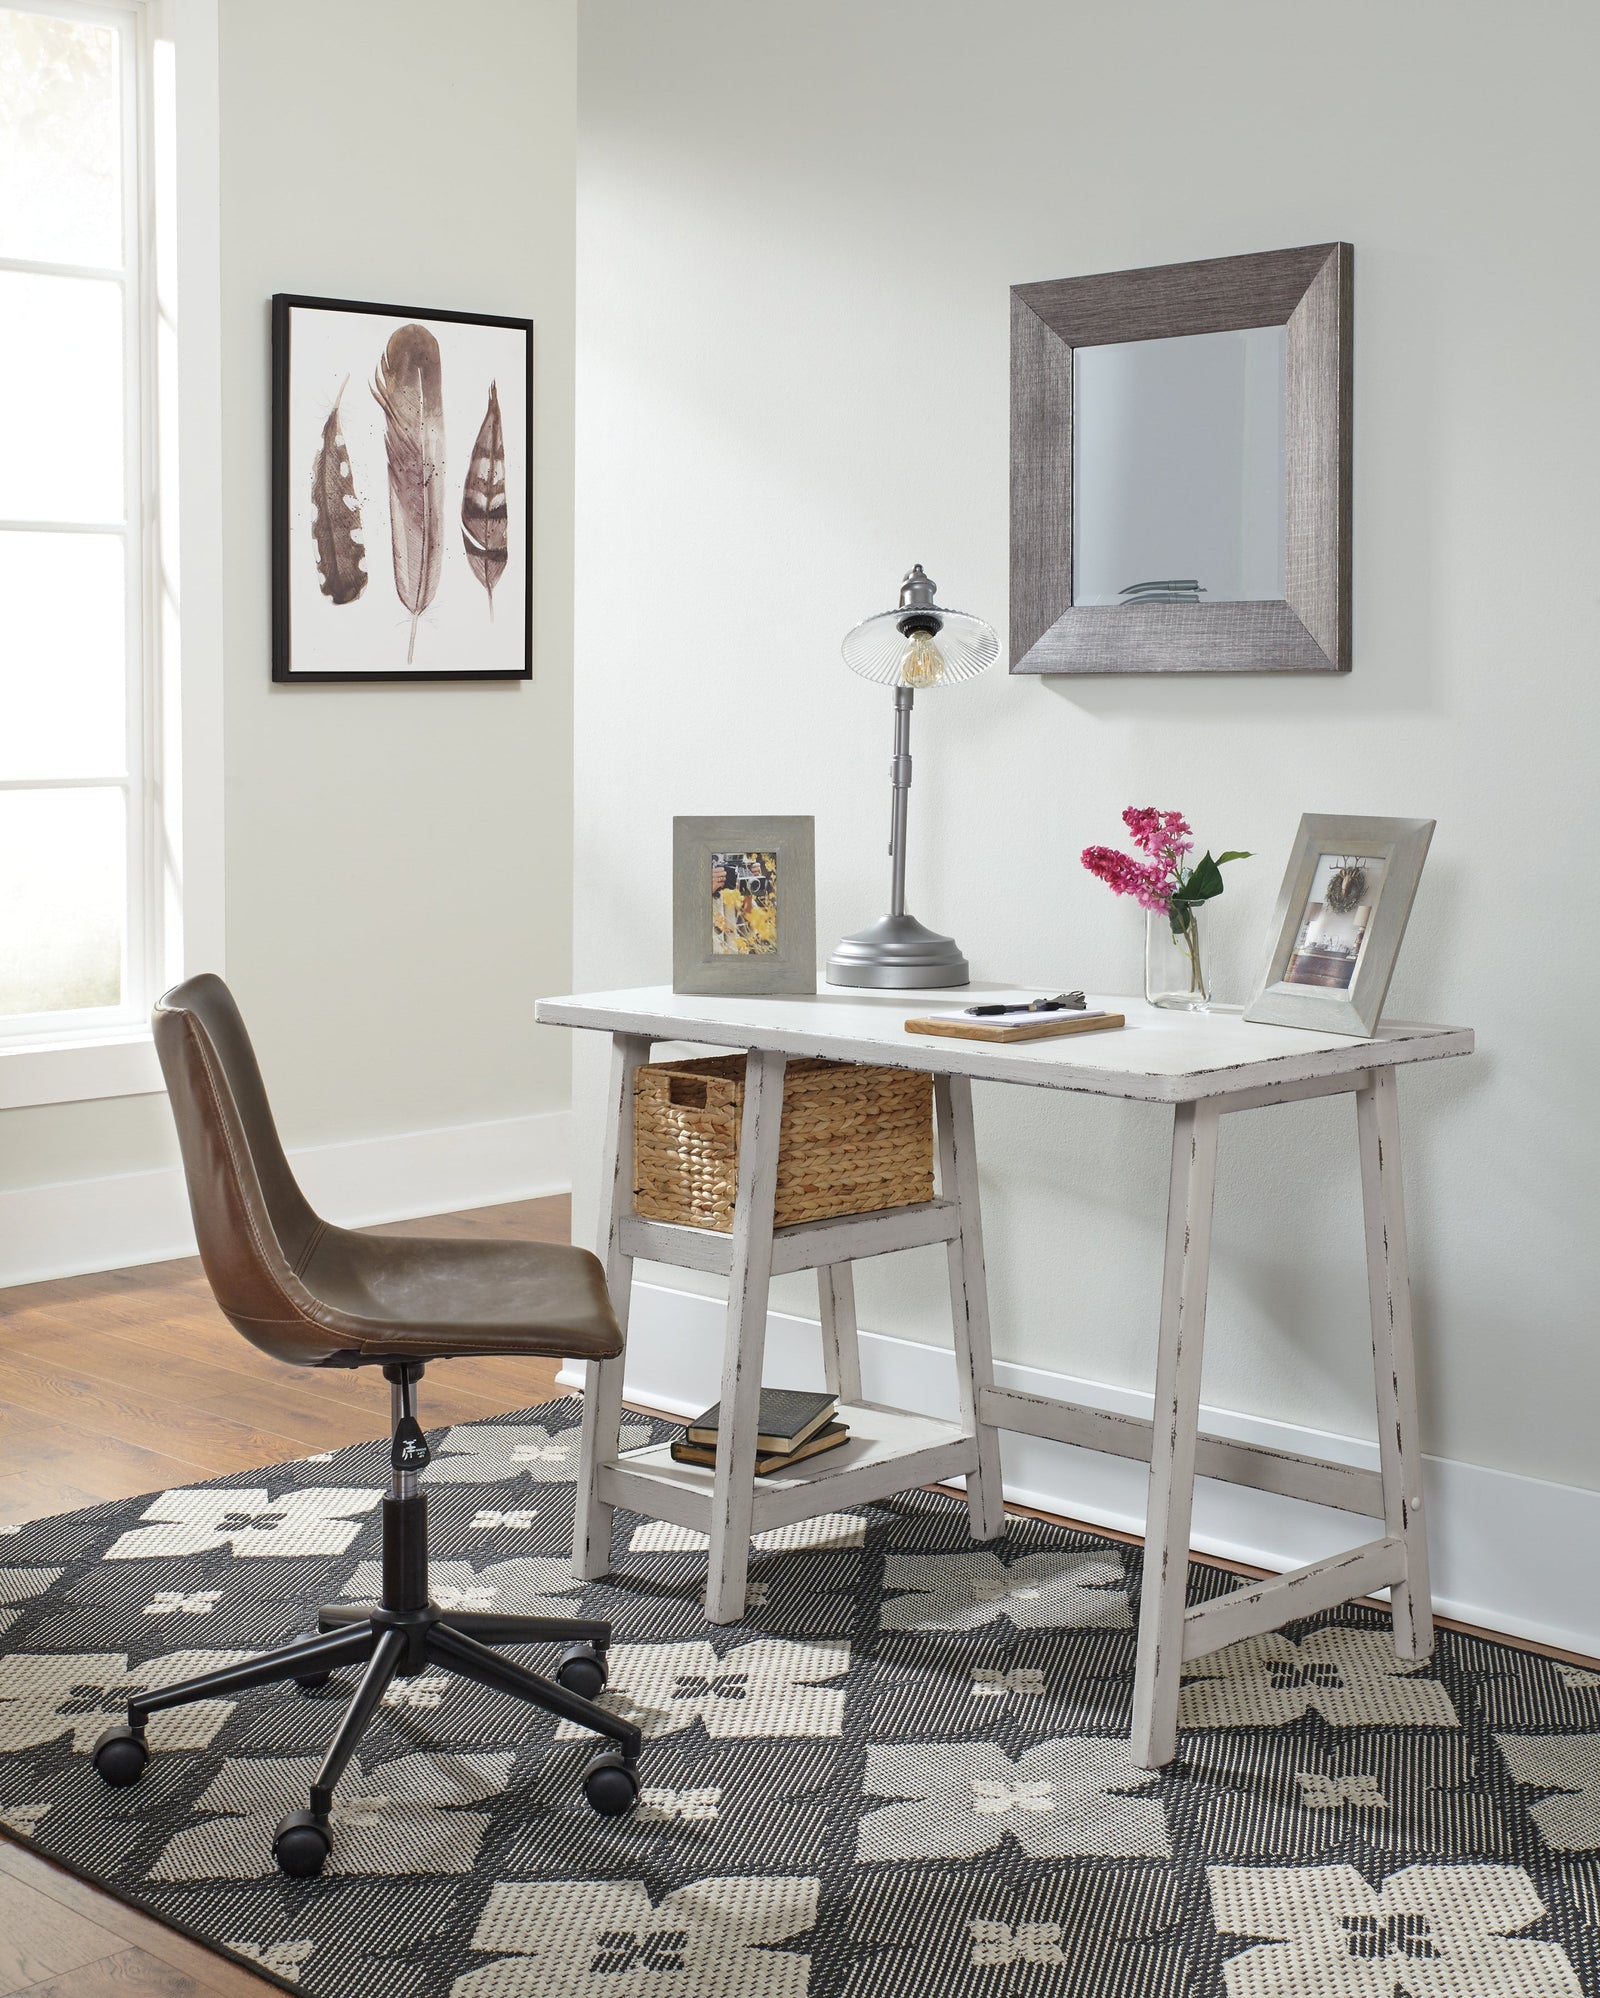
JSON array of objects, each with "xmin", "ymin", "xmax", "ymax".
[{"xmin": 1244, "ymin": 811, "xmax": 1434, "ymax": 1037}]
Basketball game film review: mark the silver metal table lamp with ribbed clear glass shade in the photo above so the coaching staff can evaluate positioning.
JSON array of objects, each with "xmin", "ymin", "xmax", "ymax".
[{"xmin": 827, "ymin": 561, "xmax": 1001, "ymax": 991}]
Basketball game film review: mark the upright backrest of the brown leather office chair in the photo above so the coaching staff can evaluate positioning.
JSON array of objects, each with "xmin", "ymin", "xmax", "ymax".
[{"xmin": 152, "ymin": 971, "xmax": 328, "ymax": 1359}]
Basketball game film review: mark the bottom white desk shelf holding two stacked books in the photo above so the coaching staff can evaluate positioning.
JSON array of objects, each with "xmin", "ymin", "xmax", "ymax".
[{"xmin": 599, "ymin": 1403, "xmax": 977, "ymax": 1532}]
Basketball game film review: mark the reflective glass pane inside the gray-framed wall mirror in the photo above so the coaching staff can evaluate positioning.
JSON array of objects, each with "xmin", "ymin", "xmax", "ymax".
[{"xmin": 1073, "ymin": 326, "xmax": 1288, "ymax": 603}]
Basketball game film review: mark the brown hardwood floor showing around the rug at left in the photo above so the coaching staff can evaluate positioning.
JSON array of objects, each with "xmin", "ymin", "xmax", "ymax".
[{"xmin": 0, "ymin": 1199, "xmax": 569, "ymax": 1998}]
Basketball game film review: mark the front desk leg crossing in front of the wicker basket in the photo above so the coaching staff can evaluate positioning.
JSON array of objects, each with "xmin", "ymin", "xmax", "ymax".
[{"xmin": 705, "ymin": 1049, "xmax": 785, "ymax": 1622}]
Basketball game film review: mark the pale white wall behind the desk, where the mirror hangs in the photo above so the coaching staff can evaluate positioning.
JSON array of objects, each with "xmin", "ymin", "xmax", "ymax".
[{"xmin": 575, "ymin": 0, "xmax": 1600, "ymax": 1489}]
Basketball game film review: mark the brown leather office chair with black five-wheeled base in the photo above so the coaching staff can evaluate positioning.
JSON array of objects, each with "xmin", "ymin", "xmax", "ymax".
[{"xmin": 94, "ymin": 973, "xmax": 639, "ymax": 1876}]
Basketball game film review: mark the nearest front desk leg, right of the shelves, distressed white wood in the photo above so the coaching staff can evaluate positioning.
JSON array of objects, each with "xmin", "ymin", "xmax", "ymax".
[{"xmin": 1131, "ymin": 1103, "xmax": 1220, "ymax": 1768}]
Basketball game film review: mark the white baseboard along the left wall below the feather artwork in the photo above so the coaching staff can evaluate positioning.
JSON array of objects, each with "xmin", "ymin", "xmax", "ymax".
[{"xmin": 0, "ymin": 1111, "xmax": 571, "ymax": 1287}]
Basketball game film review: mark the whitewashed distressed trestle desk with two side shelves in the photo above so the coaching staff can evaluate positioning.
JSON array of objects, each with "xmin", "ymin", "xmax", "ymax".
[{"xmin": 537, "ymin": 987, "xmax": 1472, "ymax": 1768}]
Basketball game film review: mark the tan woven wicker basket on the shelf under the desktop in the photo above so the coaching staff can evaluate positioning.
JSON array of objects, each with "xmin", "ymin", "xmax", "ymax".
[{"xmin": 633, "ymin": 1055, "xmax": 933, "ymax": 1235}]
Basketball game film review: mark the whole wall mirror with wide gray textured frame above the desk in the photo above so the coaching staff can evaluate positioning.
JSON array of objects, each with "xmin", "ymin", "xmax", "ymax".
[{"xmin": 1011, "ymin": 244, "xmax": 1352, "ymax": 673}]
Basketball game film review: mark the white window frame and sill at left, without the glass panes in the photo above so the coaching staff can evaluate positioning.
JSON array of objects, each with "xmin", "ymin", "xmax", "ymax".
[{"xmin": 0, "ymin": 0, "xmax": 224, "ymax": 1109}]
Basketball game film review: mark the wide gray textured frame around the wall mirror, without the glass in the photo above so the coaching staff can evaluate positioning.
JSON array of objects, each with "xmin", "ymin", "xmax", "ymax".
[{"xmin": 1011, "ymin": 244, "xmax": 1354, "ymax": 673}]
